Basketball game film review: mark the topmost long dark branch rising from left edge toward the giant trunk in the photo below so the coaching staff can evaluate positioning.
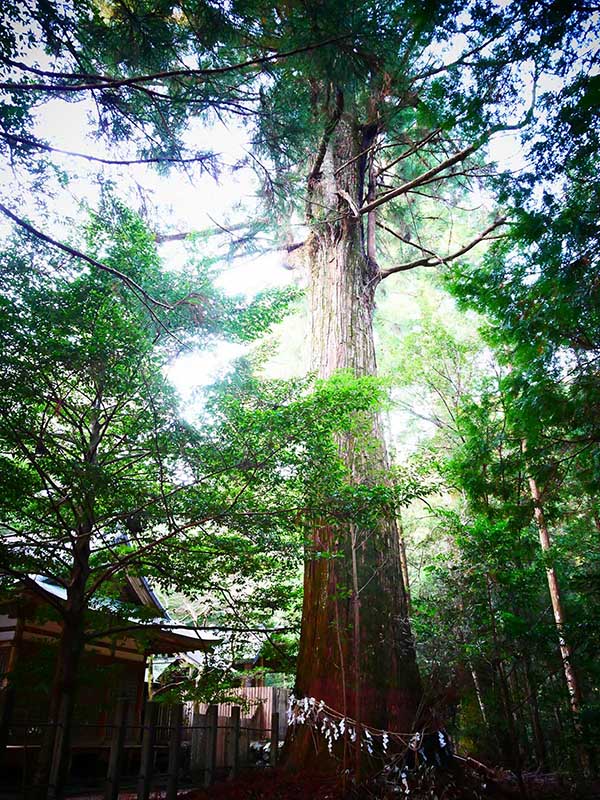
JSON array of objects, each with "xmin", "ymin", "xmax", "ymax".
[{"xmin": 0, "ymin": 34, "xmax": 349, "ymax": 92}]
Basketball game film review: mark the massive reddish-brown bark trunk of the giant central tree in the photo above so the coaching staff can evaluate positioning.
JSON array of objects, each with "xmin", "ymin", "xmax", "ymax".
[{"xmin": 289, "ymin": 109, "xmax": 421, "ymax": 765}]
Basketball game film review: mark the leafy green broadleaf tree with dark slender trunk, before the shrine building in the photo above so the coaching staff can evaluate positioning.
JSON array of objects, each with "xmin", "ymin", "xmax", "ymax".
[{"xmin": 0, "ymin": 199, "xmax": 398, "ymax": 793}]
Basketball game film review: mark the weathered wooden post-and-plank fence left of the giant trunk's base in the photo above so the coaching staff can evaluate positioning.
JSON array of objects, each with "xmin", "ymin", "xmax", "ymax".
[{"xmin": 0, "ymin": 687, "xmax": 287, "ymax": 800}]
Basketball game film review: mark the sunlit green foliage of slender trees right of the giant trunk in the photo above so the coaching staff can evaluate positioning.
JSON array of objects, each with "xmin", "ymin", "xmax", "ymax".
[{"xmin": 383, "ymin": 256, "xmax": 599, "ymax": 768}]
